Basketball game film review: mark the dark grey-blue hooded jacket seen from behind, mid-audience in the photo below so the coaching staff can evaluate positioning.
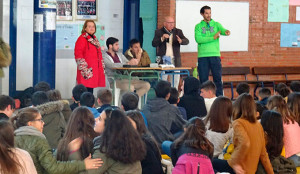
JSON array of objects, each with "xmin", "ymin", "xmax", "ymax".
[{"xmin": 142, "ymin": 98, "xmax": 186, "ymax": 147}]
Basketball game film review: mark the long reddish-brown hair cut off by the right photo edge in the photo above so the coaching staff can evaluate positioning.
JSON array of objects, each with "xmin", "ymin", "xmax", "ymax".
[{"xmin": 287, "ymin": 92, "xmax": 300, "ymax": 126}]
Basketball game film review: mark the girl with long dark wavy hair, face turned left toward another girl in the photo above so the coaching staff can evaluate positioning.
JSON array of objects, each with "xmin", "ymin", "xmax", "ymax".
[{"xmin": 88, "ymin": 108, "xmax": 146, "ymax": 174}]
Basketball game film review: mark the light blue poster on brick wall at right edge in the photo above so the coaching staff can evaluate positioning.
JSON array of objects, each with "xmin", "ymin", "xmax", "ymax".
[{"xmin": 280, "ymin": 24, "xmax": 300, "ymax": 47}]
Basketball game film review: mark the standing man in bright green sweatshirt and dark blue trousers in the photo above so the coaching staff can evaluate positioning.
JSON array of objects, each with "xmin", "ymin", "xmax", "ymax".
[{"xmin": 195, "ymin": 6, "xmax": 230, "ymax": 96}]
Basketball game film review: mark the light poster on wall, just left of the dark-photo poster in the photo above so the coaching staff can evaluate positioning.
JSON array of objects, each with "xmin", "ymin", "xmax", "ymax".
[{"xmin": 56, "ymin": 0, "xmax": 73, "ymax": 20}]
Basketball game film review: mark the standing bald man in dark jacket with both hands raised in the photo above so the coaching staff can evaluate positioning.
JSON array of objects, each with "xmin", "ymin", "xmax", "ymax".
[{"xmin": 152, "ymin": 16, "xmax": 189, "ymax": 88}]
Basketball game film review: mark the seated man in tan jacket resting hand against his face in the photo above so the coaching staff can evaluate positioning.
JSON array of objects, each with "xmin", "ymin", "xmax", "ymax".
[{"xmin": 124, "ymin": 39, "xmax": 151, "ymax": 67}]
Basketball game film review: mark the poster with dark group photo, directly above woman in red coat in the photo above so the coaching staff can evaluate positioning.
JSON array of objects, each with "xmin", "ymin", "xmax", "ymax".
[{"xmin": 76, "ymin": 0, "xmax": 97, "ymax": 20}]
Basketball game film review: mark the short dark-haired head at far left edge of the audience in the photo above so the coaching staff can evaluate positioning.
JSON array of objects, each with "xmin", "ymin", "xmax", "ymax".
[{"xmin": 0, "ymin": 95, "xmax": 15, "ymax": 117}]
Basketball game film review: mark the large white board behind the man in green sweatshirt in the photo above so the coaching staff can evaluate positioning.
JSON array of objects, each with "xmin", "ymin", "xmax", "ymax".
[{"xmin": 176, "ymin": 0, "xmax": 249, "ymax": 52}]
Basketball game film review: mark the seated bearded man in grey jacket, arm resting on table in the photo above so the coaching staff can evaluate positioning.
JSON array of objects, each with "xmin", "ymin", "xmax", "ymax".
[{"xmin": 103, "ymin": 37, "xmax": 150, "ymax": 97}]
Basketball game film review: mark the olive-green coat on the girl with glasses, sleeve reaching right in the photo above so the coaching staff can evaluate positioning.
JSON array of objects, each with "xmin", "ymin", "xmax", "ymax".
[{"xmin": 15, "ymin": 126, "xmax": 85, "ymax": 174}]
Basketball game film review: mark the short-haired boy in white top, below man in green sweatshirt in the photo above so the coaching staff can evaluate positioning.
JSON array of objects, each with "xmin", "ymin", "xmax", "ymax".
[{"xmin": 200, "ymin": 80, "xmax": 217, "ymax": 114}]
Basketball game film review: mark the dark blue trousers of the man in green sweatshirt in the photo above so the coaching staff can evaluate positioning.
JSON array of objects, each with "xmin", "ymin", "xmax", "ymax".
[{"xmin": 198, "ymin": 57, "xmax": 223, "ymax": 96}]
